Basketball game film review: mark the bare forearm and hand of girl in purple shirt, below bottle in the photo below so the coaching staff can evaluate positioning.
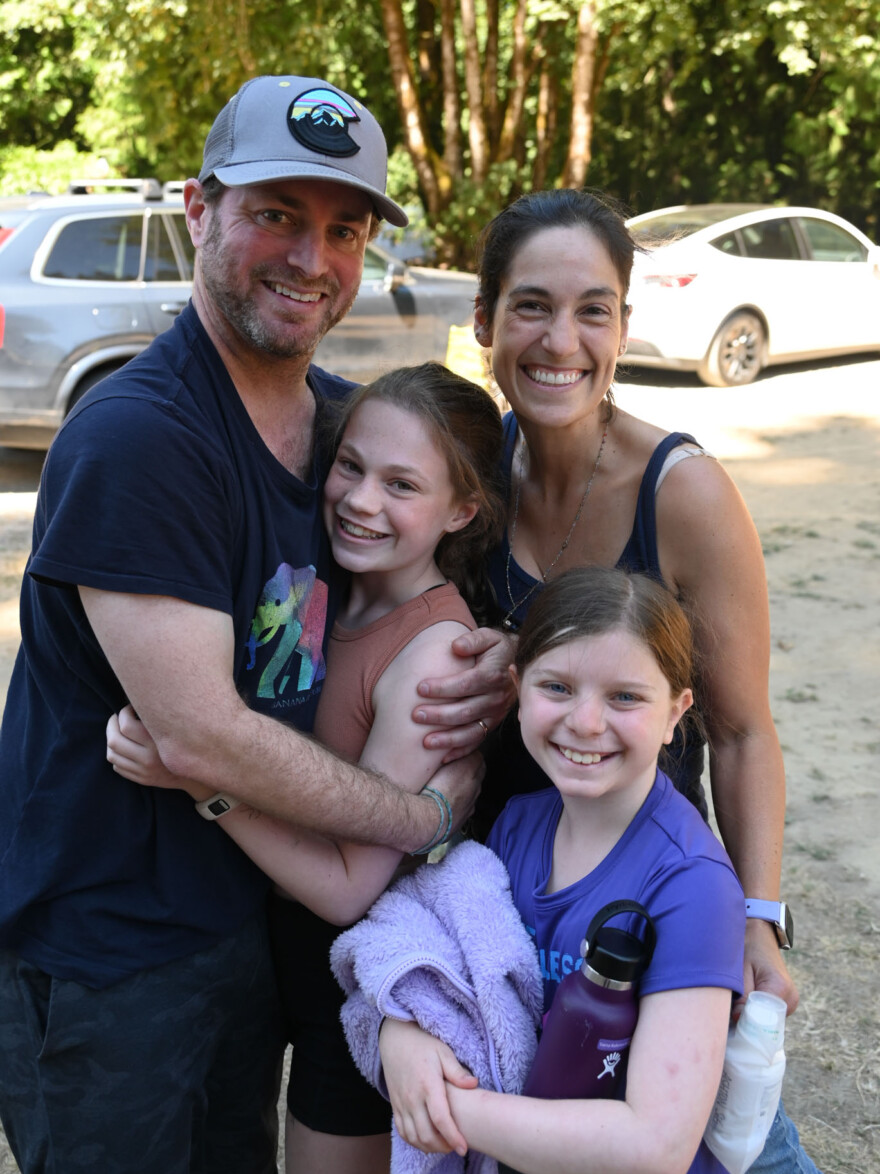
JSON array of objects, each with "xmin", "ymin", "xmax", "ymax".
[{"xmin": 383, "ymin": 987, "xmax": 730, "ymax": 1174}]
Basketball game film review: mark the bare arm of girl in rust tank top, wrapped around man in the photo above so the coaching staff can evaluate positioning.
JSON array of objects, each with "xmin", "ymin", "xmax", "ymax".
[{"xmin": 108, "ymin": 622, "xmax": 483, "ymax": 925}]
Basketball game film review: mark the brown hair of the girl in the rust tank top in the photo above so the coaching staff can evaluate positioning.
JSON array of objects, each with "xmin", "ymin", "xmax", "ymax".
[{"xmin": 333, "ymin": 363, "xmax": 507, "ymax": 619}]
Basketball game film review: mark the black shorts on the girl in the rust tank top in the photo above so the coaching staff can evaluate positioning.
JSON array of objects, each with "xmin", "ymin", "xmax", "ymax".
[{"xmin": 269, "ymin": 896, "xmax": 391, "ymax": 1138}]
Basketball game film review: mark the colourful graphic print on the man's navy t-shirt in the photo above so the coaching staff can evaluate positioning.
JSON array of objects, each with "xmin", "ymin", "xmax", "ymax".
[{"xmin": 245, "ymin": 562, "xmax": 327, "ymax": 701}]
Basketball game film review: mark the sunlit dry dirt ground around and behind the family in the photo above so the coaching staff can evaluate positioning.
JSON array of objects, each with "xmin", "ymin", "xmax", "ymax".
[{"xmin": 0, "ymin": 360, "xmax": 880, "ymax": 1174}]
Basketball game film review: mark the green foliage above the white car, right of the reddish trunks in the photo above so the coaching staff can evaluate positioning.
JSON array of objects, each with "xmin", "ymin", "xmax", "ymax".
[{"xmin": 590, "ymin": 0, "xmax": 880, "ymax": 234}]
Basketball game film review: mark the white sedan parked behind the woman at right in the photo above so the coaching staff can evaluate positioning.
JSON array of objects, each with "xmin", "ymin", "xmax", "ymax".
[{"xmin": 624, "ymin": 204, "xmax": 880, "ymax": 387}]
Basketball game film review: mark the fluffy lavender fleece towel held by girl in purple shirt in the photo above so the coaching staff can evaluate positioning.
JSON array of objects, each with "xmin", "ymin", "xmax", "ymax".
[{"xmin": 330, "ymin": 842, "xmax": 543, "ymax": 1174}]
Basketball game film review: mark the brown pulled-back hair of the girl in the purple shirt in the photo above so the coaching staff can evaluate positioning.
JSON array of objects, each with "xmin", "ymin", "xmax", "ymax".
[{"xmin": 514, "ymin": 567, "xmax": 695, "ymax": 697}]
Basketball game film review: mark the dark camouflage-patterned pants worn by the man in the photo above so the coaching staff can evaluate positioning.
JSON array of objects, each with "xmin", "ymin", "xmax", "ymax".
[{"xmin": 0, "ymin": 918, "xmax": 284, "ymax": 1174}]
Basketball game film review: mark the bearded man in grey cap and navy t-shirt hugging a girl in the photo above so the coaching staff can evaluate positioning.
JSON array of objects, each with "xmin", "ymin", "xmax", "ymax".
[{"xmin": 0, "ymin": 77, "xmax": 499, "ymax": 1174}]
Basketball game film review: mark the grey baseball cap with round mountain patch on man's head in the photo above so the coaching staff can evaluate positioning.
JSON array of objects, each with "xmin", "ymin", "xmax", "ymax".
[{"xmin": 198, "ymin": 77, "xmax": 409, "ymax": 228}]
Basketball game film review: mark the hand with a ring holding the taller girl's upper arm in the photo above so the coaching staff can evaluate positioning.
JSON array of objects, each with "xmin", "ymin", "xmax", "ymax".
[{"xmin": 413, "ymin": 628, "xmax": 516, "ymax": 762}]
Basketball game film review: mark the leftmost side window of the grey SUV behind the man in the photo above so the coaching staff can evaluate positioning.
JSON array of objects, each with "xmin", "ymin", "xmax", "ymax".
[{"xmin": 43, "ymin": 214, "xmax": 143, "ymax": 282}]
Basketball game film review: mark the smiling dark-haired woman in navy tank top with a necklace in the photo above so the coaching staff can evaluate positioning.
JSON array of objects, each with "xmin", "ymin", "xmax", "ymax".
[{"xmin": 417, "ymin": 190, "xmax": 815, "ymax": 1170}]
